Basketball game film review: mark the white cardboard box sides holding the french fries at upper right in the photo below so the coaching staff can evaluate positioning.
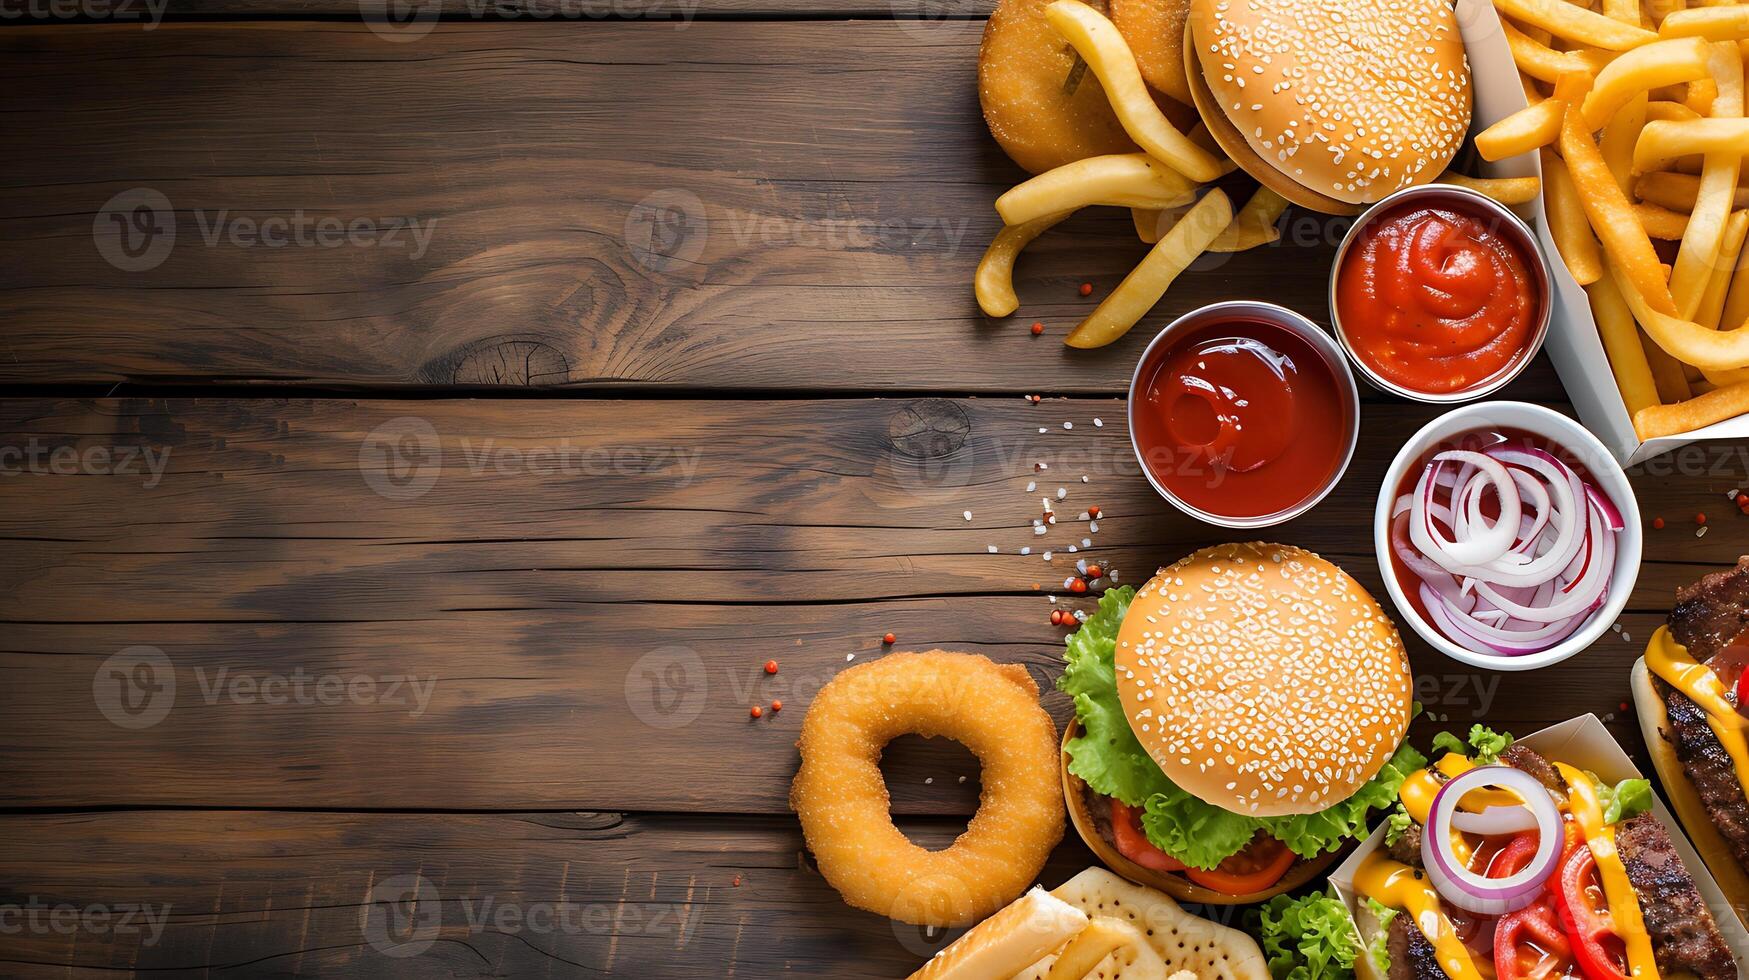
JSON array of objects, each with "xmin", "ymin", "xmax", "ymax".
[{"xmin": 1457, "ymin": 0, "xmax": 1749, "ymax": 467}]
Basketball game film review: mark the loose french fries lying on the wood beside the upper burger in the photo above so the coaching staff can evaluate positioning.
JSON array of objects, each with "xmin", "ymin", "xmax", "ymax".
[{"xmin": 972, "ymin": 0, "xmax": 1541, "ymax": 348}]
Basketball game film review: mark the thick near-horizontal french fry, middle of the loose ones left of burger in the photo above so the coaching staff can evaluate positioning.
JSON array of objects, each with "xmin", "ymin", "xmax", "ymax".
[{"xmin": 995, "ymin": 154, "xmax": 1196, "ymax": 224}]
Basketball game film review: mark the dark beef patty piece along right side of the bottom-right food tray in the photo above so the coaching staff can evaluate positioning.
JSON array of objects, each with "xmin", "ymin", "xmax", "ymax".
[{"xmin": 1616, "ymin": 814, "xmax": 1737, "ymax": 980}]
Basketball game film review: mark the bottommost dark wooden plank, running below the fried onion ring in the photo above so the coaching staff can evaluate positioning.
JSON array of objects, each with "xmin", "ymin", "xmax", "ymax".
[{"xmin": 0, "ymin": 812, "xmax": 1093, "ymax": 980}]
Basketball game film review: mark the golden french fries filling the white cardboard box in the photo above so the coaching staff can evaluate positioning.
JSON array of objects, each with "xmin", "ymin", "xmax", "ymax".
[{"xmin": 1476, "ymin": 0, "xmax": 1749, "ymax": 441}]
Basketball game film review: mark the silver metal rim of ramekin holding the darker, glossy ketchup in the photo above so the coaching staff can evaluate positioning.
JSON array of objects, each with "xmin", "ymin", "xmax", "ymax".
[{"xmin": 1125, "ymin": 299, "xmax": 1361, "ymax": 530}]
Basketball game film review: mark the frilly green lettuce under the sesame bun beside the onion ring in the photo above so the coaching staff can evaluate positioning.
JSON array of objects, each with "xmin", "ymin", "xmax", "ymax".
[{"xmin": 1056, "ymin": 586, "xmax": 1427, "ymax": 868}]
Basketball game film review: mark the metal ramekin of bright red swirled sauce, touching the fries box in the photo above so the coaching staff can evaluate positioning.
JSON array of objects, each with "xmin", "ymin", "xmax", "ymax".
[{"xmin": 1329, "ymin": 184, "xmax": 1553, "ymax": 404}]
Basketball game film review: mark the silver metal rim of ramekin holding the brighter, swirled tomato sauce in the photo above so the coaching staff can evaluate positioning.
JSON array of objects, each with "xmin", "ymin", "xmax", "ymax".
[{"xmin": 1329, "ymin": 184, "xmax": 1555, "ymax": 404}]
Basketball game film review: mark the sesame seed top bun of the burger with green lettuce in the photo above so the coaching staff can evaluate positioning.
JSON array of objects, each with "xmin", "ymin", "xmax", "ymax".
[{"xmin": 1116, "ymin": 544, "xmax": 1411, "ymax": 817}]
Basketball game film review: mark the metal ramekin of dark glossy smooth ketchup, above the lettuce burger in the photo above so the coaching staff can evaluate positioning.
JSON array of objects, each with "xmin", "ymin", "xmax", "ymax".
[{"xmin": 1126, "ymin": 301, "xmax": 1361, "ymax": 529}]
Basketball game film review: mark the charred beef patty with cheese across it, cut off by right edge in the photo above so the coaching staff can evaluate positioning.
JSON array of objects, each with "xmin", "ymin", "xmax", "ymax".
[{"xmin": 1653, "ymin": 558, "xmax": 1749, "ymax": 882}]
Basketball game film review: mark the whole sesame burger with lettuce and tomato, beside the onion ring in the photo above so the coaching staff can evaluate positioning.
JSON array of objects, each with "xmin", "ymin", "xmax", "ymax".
[{"xmin": 1058, "ymin": 544, "xmax": 1425, "ymax": 903}]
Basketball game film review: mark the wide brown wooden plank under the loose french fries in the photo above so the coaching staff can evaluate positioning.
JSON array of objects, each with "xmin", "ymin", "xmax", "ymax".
[{"xmin": 0, "ymin": 21, "xmax": 1560, "ymax": 399}]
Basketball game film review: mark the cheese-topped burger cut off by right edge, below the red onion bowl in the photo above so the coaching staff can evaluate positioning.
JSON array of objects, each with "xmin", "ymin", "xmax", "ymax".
[{"xmin": 1634, "ymin": 558, "xmax": 1749, "ymax": 921}]
